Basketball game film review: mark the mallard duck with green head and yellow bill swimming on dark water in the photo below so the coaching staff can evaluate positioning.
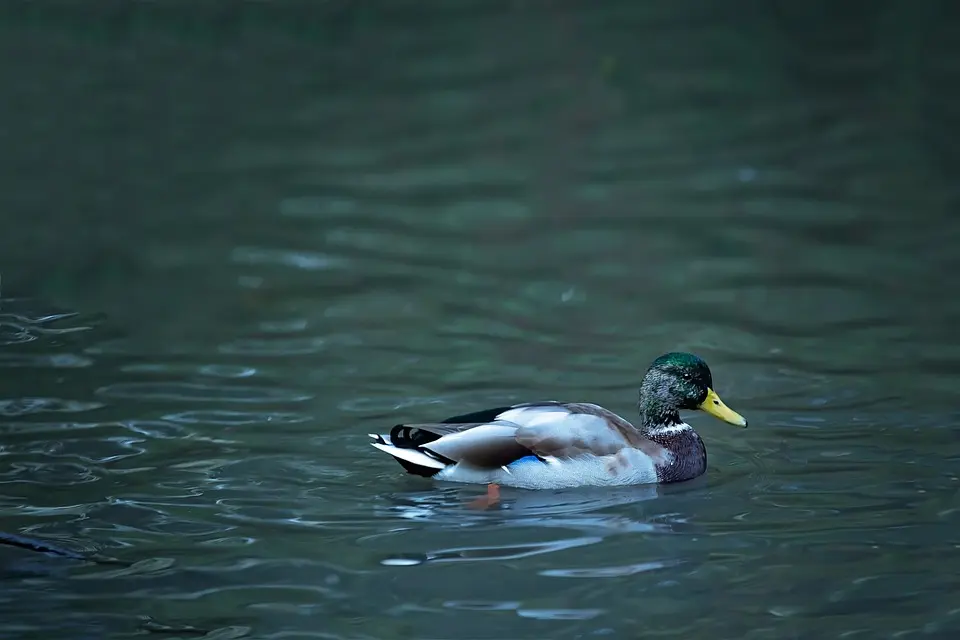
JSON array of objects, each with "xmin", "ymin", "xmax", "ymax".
[{"xmin": 370, "ymin": 353, "xmax": 747, "ymax": 489}]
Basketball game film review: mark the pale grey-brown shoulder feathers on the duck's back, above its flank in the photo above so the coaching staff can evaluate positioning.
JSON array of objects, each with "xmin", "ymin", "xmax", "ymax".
[{"xmin": 500, "ymin": 402, "xmax": 668, "ymax": 463}]
